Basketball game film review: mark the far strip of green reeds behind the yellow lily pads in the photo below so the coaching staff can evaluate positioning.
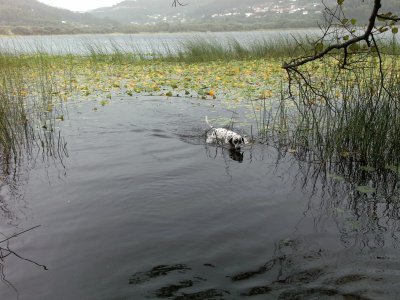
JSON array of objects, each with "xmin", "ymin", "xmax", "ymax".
[{"xmin": 81, "ymin": 35, "xmax": 314, "ymax": 63}]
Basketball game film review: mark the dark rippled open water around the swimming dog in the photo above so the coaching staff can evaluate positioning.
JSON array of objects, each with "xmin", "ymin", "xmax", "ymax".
[{"xmin": 0, "ymin": 97, "xmax": 400, "ymax": 300}]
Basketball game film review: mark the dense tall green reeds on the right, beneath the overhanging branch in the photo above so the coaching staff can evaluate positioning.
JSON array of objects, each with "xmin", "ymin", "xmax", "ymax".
[{"xmin": 250, "ymin": 50, "xmax": 400, "ymax": 184}]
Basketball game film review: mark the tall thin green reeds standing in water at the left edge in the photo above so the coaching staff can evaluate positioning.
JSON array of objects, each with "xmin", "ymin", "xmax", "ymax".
[{"xmin": 0, "ymin": 53, "xmax": 68, "ymax": 180}]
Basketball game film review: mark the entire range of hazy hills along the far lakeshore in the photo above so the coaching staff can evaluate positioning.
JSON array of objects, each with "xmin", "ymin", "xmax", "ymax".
[{"xmin": 0, "ymin": 0, "xmax": 399, "ymax": 34}]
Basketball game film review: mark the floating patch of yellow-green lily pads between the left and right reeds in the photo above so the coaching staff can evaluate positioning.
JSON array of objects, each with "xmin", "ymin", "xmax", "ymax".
[{"xmin": 23, "ymin": 59, "xmax": 286, "ymax": 108}]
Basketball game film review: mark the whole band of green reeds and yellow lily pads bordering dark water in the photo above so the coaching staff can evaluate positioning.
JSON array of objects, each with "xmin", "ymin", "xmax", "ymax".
[{"xmin": 0, "ymin": 37, "xmax": 400, "ymax": 193}]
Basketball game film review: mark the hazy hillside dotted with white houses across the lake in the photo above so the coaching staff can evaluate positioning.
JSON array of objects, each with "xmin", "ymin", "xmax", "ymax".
[{"xmin": 90, "ymin": 0, "xmax": 400, "ymax": 30}]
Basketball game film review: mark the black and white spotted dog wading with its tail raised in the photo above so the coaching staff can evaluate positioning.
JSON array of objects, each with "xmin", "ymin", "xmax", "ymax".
[{"xmin": 206, "ymin": 116, "xmax": 248, "ymax": 150}]
